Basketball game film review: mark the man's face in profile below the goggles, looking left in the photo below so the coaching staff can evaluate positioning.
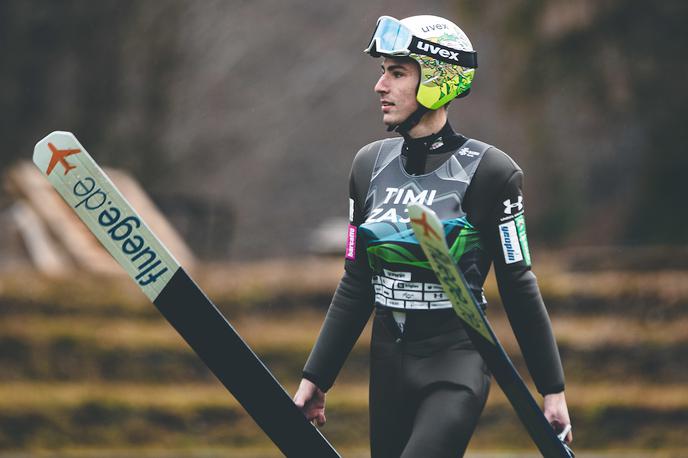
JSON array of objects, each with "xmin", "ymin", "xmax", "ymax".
[{"xmin": 375, "ymin": 57, "xmax": 420, "ymax": 126}]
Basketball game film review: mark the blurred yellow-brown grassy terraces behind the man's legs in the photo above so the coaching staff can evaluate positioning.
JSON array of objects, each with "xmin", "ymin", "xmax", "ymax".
[{"xmin": 0, "ymin": 260, "xmax": 688, "ymax": 452}]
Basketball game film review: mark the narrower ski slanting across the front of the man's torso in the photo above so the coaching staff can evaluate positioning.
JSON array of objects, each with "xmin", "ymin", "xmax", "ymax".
[{"xmin": 408, "ymin": 204, "xmax": 574, "ymax": 458}]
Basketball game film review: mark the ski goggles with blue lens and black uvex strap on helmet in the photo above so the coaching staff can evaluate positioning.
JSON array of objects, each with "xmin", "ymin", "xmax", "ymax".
[{"xmin": 363, "ymin": 16, "xmax": 478, "ymax": 68}]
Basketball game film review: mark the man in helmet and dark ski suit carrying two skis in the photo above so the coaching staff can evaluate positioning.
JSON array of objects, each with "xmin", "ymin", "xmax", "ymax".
[{"xmin": 294, "ymin": 16, "xmax": 572, "ymax": 458}]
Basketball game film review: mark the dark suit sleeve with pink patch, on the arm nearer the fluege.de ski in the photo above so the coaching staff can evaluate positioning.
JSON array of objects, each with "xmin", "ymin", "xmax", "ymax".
[{"xmin": 303, "ymin": 148, "xmax": 374, "ymax": 391}]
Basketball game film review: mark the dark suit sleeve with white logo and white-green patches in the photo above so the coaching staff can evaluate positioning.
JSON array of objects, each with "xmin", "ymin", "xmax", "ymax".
[{"xmin": 476, "ymin": 152, "xmax": 564, "ymax": 395}]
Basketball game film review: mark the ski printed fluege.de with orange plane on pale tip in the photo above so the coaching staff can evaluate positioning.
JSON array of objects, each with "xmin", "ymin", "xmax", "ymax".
[{"xmin": 33, "ymin": 131, "xmax": 340, "ymax": 458}]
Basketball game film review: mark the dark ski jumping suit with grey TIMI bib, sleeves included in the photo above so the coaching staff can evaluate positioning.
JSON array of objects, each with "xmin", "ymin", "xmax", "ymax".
[{"xmin": 303, "ymin": 123, "xmax": 564, "ymax": 458}]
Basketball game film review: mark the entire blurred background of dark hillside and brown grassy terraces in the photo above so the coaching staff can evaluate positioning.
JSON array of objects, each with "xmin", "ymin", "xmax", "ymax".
[{"xmin": 0, "ymin": 0, "xmax": 688, "ymax": 457}]
